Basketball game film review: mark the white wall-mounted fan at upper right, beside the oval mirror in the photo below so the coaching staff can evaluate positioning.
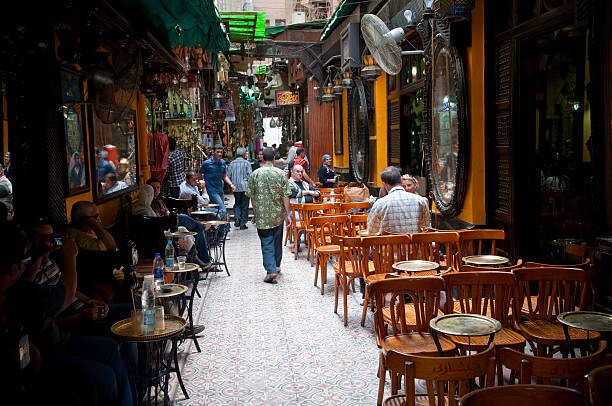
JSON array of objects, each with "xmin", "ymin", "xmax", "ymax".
[{"xmin": 361, "ymin": 10, "xmax": 423, "ymax": 75}]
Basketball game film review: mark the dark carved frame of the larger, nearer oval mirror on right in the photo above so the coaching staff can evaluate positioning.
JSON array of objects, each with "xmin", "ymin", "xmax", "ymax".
[{"xmin": 420, "ymin": 26, "xmax": 470, "ymax": 217}]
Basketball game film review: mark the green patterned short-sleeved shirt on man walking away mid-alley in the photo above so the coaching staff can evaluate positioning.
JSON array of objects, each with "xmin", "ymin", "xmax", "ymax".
[{"xmin": 246, "ymin": 162, "xmax": 291, "ymax": 230}]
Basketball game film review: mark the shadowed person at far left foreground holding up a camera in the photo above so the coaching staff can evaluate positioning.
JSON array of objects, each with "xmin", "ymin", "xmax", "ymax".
[{"xmin": 0, "ymin": 224, "xmax": 134, "ymax": 406}]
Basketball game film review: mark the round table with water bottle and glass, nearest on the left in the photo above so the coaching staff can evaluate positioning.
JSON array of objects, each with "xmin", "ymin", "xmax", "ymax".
[{"xmin": 111, "ymin": 315, "xmax": 189, "ymax": 404}]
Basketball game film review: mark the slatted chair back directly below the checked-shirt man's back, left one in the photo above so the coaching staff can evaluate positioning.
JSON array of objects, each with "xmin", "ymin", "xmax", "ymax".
[{"xmin": 361, "ymin": 234, "xmax": 410, "ymax": 276}]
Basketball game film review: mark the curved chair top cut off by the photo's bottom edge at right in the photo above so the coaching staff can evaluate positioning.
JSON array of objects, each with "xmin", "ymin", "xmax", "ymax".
[{"xmin": 459, "ymin": 384, "xmax": 589, "ymax": 406}]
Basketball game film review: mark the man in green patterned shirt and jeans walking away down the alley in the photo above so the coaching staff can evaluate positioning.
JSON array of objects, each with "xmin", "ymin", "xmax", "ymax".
[{"xmin": 246, "ymin": 148, "xmax": 291, "ymax": 284}]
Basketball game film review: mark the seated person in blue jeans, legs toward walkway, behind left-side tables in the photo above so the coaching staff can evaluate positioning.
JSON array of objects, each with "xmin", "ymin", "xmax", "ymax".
[{"xmin": 140, "ymin": 178, "xmax": 213, "ymax": 270}]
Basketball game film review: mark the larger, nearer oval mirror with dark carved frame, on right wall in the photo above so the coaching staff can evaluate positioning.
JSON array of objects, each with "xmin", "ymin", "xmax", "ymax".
[{"xmin": 424, "ymin": 34, "xmax": 468, "ymax": 216}]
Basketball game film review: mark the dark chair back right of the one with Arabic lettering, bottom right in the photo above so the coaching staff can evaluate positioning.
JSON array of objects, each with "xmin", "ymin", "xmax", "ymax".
[{"xmin": 497, "ymin": 340, "xmax": 607, "ymax": 393}]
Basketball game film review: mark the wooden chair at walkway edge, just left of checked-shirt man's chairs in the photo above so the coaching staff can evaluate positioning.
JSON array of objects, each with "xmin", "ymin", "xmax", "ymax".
[{"xmin": 332, "ymin": 235, "xmax": 373, "ymax": 326}]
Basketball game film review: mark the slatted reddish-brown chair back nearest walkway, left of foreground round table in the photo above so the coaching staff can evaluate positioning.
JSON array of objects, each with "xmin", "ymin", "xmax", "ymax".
[{"xmin": 370, "ymin": 276, "xmax": 444, "ymax": 336}]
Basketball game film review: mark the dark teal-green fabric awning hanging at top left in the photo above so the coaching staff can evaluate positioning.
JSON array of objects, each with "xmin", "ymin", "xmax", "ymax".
[{"xmin": 117, "ymin": 0, "xmax": 230, "ymax": 55}]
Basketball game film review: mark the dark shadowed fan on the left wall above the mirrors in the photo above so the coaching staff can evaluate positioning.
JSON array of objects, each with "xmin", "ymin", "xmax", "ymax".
[{"xmin": 91, "ymin": 48, "xmax": 143, "ymax": 124}]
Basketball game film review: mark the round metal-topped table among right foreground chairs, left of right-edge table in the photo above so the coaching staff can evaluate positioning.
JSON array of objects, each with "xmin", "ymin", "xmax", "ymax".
[{"xmin": 429, "ymin": 313, "xmax": 502, "ymax": 356}]
